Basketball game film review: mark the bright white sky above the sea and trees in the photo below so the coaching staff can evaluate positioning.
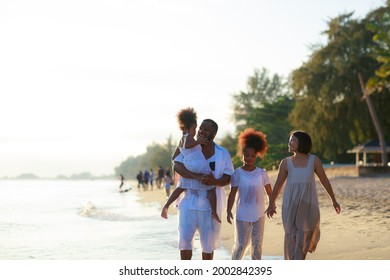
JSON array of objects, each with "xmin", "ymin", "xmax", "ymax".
[{"xmin": 0, "ymin": 0, "xmax": 385, "ymax": 177}]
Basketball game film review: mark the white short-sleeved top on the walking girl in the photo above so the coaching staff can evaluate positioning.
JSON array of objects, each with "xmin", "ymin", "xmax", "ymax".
[{"xmin": 231, "ymin": 167, "xmax": 269, "ymax": 222}]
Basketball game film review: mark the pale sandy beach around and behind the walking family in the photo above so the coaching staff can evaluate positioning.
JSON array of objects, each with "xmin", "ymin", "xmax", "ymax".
[{"xmin": 138, "ymin": 171, "xmax": 390, "ymax": 260}]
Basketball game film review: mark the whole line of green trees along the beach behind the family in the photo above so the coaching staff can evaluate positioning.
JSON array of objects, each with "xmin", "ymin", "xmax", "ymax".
[{"xmin": 115, "ymin": 0, "xmax": 390, "ymax": 177}]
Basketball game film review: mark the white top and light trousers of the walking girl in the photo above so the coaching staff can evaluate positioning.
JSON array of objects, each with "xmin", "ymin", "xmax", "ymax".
[{"xmin": 231, "ymin": 167, "xmax": 269, "ymax": 260}]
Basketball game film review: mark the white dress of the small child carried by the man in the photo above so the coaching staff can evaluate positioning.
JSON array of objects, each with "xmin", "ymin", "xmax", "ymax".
[{"xmin": 180, "ymin": 133, "xmax": 214, "ymax": 190}]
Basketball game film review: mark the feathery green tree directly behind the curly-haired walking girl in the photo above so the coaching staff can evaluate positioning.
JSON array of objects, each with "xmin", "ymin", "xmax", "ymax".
[{"xmin": 227, "ymin": 68, "xmax": 294, "ymax": 169}]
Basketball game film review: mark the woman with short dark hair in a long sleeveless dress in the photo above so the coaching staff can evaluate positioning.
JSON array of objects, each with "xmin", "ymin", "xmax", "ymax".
[{"xmin": 266, "ymin": 130, "xmax": 341, "ymax": 260}]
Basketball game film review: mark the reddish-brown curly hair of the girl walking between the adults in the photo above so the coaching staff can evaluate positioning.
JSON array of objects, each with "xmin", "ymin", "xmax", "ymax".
[{"xmin": 237, "ymin": 128, "xmax": 268, "ymax": 159}]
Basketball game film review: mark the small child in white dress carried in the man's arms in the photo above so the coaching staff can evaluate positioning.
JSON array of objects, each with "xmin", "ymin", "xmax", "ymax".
[{"xmin": 161, "ymin": 108, "xmax": 221, "ymax": 222}]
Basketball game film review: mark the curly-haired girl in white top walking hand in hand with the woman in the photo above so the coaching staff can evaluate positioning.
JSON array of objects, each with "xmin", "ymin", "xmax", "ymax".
[{"xmin": 227, "ymin": 128, "xmax": 272, "ymax": 260}]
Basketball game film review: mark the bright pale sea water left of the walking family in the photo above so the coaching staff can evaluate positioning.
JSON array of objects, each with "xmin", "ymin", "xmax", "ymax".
[{"xmin": 0, "ymin": 180, "xmax": 230, "ymax": 260}]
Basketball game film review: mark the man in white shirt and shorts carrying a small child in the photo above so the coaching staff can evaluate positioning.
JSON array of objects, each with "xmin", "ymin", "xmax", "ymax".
[{"xmin": 174, "ymin": 119, "xmax": 233, "ymax": 260}]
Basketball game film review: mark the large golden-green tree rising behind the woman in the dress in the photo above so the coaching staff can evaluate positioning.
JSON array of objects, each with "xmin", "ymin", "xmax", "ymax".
[{"xmin": 289, "ymin": 10, "xmax": 390, "ymax": 161}]
